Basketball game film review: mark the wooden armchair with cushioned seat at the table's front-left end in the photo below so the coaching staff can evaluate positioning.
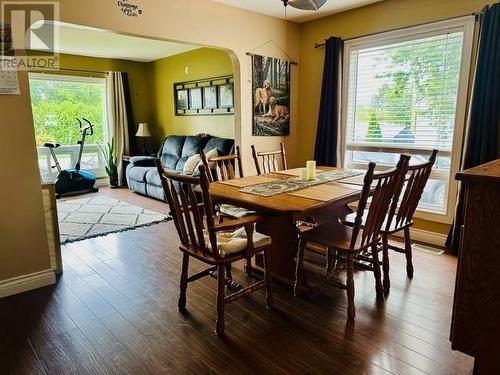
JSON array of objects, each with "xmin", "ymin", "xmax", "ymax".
[{"xmin": 156, "ymin": 159, "xmax": 273, "ymax": 335}]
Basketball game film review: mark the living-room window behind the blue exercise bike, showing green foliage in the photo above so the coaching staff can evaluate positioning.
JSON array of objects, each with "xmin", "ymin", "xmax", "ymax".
[{"xmin": 29, "ymin": 73, "xmax": 108, "ymax": 182}]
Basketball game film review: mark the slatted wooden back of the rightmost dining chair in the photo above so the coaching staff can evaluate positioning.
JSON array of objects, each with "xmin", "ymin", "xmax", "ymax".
[{"xmin": 393, "ymin": 150, "xmax": 438, "ymax": 227}]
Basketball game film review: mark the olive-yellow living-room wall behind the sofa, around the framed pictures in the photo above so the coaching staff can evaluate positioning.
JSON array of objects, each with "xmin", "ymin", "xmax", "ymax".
[{"xmin": 148, "ymin": 48, "xmax": 235, "ymax": 147}]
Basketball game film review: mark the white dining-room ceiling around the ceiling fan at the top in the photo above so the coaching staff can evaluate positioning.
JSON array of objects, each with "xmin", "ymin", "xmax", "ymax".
[{"xmin": 212, "ymin": 0, "xmax": 383, "ymax": 23}]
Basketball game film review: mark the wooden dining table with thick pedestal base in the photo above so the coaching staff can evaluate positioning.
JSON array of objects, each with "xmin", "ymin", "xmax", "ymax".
[{"xmin": 210, "ymin": 166, "xmax": 364, "ymax": 286}]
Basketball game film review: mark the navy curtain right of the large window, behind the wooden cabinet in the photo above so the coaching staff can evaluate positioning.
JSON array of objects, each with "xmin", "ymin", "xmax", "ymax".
[{"xmin": 447, "ymin": 3, "xmax": 500, "ymax": 254}]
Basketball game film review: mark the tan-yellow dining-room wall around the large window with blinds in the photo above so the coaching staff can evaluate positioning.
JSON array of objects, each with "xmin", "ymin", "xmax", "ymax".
[{"xmin": 297, "ymin": 0, "xmax": 496, "ymax": 234}]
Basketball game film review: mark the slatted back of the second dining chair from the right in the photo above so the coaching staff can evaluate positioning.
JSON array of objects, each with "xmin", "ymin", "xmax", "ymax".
[{"xmin": 351, "ymin": 155, "xmax": 410, "ymax": 248}]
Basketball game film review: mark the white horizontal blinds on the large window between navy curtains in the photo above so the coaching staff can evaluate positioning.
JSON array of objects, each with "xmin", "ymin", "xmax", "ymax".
[{"xmin": 347, "ymin": 32, "xmax": 463, "ymax": 154}]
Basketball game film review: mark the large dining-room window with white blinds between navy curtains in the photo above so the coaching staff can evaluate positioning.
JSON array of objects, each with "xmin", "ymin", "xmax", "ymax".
[{"xmin": 342, "ymin": 17, "xmax": 473, "ymax": 222}]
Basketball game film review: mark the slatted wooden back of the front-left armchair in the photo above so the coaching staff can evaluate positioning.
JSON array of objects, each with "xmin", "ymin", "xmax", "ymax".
[{"xmin": 156, "ymin": 159, "xmax": 219, "ymax": 259}]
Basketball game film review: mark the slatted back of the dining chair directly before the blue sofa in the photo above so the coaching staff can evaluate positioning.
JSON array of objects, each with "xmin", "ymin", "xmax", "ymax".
[{"xmin": 200, "ymin": 146, "xmax": 244, "ymax": 182}]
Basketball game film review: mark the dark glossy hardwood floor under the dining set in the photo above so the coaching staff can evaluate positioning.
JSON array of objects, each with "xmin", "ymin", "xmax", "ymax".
[{"xmin": 0, "ymin": 190, "xmax": 472, "ymax": 374}]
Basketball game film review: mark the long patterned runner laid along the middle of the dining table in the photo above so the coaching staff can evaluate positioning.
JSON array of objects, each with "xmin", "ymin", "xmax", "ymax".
[{"xmin": 240, "ymin": 170, "xmax": 363, "ymax": 197}]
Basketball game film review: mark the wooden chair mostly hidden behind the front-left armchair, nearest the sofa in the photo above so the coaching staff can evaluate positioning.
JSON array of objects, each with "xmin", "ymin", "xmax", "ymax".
[{"xmin": 200, "ymin": 146, "xmax": 256, "ymax": 275}]
